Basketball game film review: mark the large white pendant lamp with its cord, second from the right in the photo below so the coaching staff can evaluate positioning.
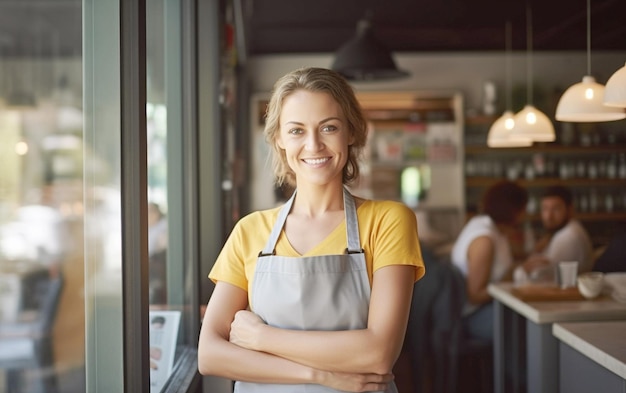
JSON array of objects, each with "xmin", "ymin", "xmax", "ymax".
[{"xmin": 555, "ymin": 0, "xmax": 626, "ymax": 122}]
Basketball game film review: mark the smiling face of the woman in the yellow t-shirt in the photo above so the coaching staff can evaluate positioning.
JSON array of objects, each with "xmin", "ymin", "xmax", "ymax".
[{"xmin": 276, "ymin": 90, "xmax": 353, "ymax": 185}]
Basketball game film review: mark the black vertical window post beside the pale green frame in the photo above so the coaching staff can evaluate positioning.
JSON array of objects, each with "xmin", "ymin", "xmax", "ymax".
[{"xmin": 119, "ymin": 0, "xmax": 150, "ymax": 393}]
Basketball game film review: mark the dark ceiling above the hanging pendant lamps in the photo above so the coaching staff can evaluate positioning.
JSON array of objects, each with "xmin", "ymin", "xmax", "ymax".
[{"xmin": 242, "ymin": 0, "xmax": 626, "ymax": 55}]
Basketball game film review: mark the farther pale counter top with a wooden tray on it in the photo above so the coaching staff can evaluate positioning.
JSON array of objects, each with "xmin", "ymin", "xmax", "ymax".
[{"xmin": 488, "ymin": 282, "xmax": 626, "ymax": 324}]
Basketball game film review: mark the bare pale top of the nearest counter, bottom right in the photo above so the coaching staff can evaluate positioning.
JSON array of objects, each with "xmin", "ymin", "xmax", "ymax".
[{"xmin": 552, "ymin": 321, "xmax": 626, "ymax": 379}]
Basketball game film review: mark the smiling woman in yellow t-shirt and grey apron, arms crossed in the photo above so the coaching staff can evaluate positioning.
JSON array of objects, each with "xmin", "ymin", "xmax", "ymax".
[{"xmin": 198, "ymin": 68, "xmax": 424, "ymax": 393}]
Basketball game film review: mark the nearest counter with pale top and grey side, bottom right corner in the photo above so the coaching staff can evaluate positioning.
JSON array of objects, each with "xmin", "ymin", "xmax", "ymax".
[{"xmin": 552, "ymin": 321, "xmax": 626, "ymax": 393}]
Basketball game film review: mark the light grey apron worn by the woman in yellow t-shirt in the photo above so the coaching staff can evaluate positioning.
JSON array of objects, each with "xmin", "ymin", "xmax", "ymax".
[{"xmin": 235, "ymin": 188, "xmax": 397, "ymax": 393}]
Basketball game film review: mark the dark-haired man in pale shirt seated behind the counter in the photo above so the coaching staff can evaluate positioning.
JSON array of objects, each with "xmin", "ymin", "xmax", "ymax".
[{"xmin": 515, "ymin": 186, "xmax": 593, "ymax": 282}]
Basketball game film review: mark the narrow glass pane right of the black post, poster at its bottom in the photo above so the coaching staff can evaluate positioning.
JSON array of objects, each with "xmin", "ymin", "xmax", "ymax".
[{"xmin": 146, "ymin": 0, "xmax": 187, "ymax": 393}]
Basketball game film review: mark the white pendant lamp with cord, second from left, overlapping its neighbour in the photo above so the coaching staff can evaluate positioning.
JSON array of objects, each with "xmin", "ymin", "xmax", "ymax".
[{"xmin": 514, "ymin": 4, "xmax": 556, "ymax": 142}]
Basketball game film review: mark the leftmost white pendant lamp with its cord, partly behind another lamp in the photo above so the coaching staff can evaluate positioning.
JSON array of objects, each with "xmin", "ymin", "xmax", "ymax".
[{"xmin": 487, "ymin": 22, "xmax": 533, "ymax": 148}]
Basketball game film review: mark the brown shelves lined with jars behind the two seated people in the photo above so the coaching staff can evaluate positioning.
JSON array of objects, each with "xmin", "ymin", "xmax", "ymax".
[{"xmin": 464, "ymin": 116, "xmax": 626, "ymax": 245}]
